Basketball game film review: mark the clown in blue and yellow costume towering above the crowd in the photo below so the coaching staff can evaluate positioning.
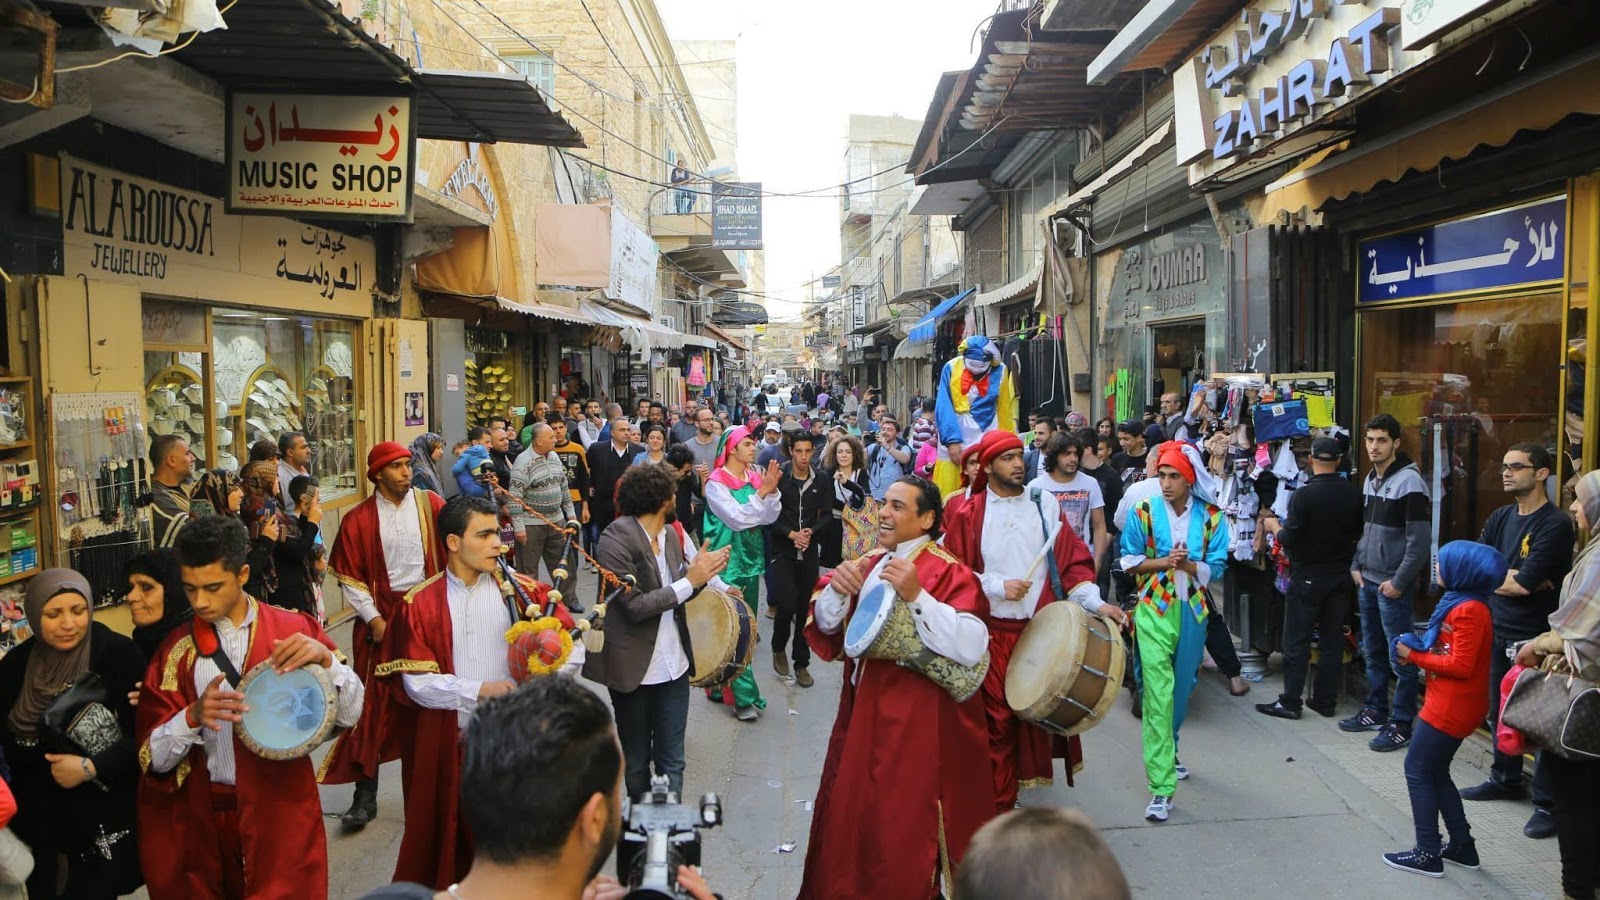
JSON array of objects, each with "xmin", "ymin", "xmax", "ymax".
[{"xmin": 933, "ymin": 335, "xmax": 1018, "ymax": 493}]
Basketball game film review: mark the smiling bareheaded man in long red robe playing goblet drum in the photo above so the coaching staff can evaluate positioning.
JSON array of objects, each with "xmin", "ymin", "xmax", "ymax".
[{"xmin": 800, "ymin": 476, "xmax": 995, "ymax": 900}]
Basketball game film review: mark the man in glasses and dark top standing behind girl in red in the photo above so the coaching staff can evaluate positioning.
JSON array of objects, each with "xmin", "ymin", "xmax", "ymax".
[{"xmin": 1461, "ymin": 444, "xmax": 1573, "ymax": 838}]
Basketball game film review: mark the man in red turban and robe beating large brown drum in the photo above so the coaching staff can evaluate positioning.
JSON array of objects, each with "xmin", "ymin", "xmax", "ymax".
[{"xmin": 944, "ymin": 431, "xmax": 1126, "ymax": 812}]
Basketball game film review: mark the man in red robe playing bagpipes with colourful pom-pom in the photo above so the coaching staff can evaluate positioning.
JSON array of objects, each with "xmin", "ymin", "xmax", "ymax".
[{"xmin": 378, "ymin": 495, "xmax": 584, "ymax": 890}]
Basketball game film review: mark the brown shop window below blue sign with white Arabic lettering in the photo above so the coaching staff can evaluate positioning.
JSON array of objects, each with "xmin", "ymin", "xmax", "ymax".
[{"xmin": 1355, "ymin": 293, "xmax": 1562, "ymax": 543}]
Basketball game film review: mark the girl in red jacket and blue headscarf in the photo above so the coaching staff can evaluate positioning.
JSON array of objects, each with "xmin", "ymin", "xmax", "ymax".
[{"xmin": 1384, "ymin": 541, "xmax": 1506, "ymax": 878}]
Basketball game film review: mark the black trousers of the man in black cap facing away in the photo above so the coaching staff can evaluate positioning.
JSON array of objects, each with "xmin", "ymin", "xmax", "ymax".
[{"xmin": 1278, "ymin": 572, "xmax": 1355, "ymax": 709}]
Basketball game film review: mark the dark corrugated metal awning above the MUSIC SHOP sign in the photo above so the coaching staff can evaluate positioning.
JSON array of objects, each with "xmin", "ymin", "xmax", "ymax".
[{"xmin": 173, "ymin": 0, "xmax": 584, "ymax": 147}]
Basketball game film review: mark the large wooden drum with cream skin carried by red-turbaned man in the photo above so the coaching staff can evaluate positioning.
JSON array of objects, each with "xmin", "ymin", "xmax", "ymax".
[{"xmin": 1005, "ymin": 602, "xmax": 1128, "ymax": 737}]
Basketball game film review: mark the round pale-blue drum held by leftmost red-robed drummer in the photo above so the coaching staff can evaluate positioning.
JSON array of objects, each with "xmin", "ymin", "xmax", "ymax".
[{"xmin": 234, "ymin": 661, "xmax": 338, "ymax": 759}]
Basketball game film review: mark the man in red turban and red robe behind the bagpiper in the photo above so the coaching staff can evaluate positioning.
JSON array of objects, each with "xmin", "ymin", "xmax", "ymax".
[{"xmin": 317, "ymin": 440, "xmax": 445, "ymax": 831}]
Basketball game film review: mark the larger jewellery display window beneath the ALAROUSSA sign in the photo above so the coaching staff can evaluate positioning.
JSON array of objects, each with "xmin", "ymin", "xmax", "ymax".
[{"xmin": 211, "ymin": 311, "xmax": 358, "ymax": 501}]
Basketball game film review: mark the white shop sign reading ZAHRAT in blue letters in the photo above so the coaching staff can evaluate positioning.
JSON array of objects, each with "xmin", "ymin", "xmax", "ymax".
[{"xmin": 1173, "ymin": 0, "xmax": 1435, "ymax": 181}]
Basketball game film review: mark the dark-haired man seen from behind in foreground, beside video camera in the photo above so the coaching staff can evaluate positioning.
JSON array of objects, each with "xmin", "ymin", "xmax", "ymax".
[{"xmin": 363, "ymin": 676, "xmax": 715, "ymax": 900}]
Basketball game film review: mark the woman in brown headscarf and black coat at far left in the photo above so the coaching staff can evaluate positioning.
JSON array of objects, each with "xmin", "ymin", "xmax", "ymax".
[{"xmin": 0, "ymin": 569, "xmax": 144, "ymax": 900}]
